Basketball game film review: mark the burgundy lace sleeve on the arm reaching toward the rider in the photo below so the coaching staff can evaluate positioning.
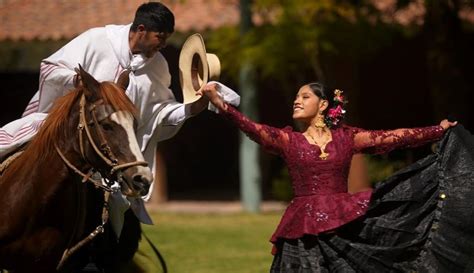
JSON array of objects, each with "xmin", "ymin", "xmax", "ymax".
[{"xmin": 219, "ymin": 105, "xmax": 291, "ymax": 154}]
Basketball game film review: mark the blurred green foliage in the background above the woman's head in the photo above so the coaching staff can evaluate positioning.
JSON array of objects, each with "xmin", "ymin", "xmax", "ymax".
[{"xmin": 207, "ymin": 0, "xmax": 408, "ymax": 98}]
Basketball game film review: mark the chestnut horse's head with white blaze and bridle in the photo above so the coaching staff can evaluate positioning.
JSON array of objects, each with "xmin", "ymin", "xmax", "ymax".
[{"xmin": 79, "ymin": 67, "xmax": 153, "ymax": 197}]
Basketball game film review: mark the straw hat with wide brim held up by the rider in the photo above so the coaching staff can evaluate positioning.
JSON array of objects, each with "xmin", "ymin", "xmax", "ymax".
[{"xmin": 179, "ymin": 33, "xmax": 221, "ymax": 103}]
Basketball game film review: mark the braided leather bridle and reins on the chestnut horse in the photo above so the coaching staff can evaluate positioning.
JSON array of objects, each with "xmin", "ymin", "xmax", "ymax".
[{"xmin": 55, "ymin": 94, "xmax": 148, "ymax": 271}]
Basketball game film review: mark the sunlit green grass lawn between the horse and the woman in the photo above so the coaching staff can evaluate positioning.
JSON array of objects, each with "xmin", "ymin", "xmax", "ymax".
[{"xmin": 136, "ymin": 212, "xmax": 281, "ymax": 273}]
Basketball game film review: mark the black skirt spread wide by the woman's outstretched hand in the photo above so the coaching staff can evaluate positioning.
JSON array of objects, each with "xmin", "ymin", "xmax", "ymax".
[{"xmin": 271, "ymin": 125, "xmax": 474, "ymax": 273}]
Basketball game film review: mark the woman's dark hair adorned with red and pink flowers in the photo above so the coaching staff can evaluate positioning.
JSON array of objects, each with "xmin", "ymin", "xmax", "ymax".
[{"xmin": 308, "ymin": 82, "xmax": 347, "ymax": 128}]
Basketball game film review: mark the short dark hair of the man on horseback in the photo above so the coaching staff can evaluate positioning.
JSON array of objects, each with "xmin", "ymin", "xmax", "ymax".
[{"xmin": 130, "ymin": 2, "xmax": 174, "ymax": 33}]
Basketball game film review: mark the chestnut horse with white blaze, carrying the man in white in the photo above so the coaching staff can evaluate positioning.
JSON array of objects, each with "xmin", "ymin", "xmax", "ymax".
[{"xmin": 0, "ymin": 67, "xmax": 152, "ymax": 273}]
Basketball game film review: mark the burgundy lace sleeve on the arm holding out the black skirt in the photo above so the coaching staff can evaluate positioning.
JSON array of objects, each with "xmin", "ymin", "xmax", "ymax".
[{"xmin": 351, "ymin": 125, "xmax": 444, "ymax": 154}]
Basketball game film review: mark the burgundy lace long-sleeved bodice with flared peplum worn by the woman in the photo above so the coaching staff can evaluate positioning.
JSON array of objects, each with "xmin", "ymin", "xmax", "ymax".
[{"xmin": 221, "ymin": 105, "xmax": 444, "ymax": 242}]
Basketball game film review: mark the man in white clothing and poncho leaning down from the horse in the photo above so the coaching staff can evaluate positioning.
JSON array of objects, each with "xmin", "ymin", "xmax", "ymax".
[{"xmin": 0, "ymin": 2, "xmax": 208, "ymax": 236}]
